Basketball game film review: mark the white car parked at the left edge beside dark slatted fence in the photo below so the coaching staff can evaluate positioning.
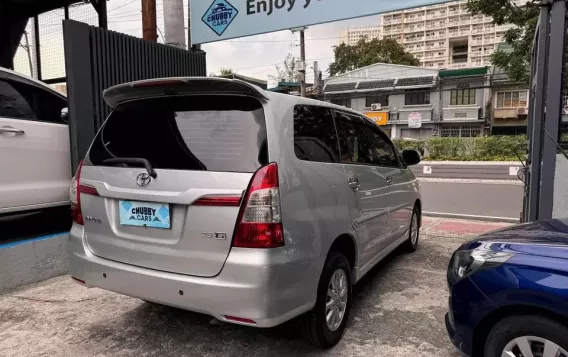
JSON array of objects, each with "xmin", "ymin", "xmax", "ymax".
[{"xmin": 0, "ymin": 67, "xmax": 72, "ymax": 217}]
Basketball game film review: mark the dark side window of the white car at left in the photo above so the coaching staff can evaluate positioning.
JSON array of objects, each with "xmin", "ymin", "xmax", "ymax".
[{"xmin": 0, "ymin": 80, "xmax": 67, "ymax": 124}]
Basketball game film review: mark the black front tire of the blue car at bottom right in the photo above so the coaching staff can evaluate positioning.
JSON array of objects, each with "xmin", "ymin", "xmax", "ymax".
[{"xmin": 484, "ymin": 315, "xmax": 568, "ymax": 357}]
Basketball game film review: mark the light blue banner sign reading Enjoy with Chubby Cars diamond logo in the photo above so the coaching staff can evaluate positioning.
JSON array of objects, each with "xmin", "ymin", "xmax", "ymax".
[{"xmin": 190, "ymin": 0, "xmax": 447, "ymax": 44}]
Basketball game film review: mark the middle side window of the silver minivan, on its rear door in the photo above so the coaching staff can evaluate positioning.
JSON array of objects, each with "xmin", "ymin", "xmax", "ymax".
[{"xmin": 335, "ymin": 112, "xmax": 374, "ymax": 165}]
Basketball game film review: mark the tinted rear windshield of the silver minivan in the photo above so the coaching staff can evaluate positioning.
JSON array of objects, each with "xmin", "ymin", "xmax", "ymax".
[{"xmin": 89, "ymin": 96, "xmax": 268, "ymax": 172}]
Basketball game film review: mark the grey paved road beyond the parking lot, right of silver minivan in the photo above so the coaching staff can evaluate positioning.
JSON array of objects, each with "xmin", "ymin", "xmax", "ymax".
[{"xmin": 420, "ymin": 182, "xmax": 523, "ymax": 219}]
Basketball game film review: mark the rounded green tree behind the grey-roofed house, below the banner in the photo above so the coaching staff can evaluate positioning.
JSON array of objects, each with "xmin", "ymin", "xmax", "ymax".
[{"xmin": 329, "ymin": 38, "xmax": 420, "ymax": 76}]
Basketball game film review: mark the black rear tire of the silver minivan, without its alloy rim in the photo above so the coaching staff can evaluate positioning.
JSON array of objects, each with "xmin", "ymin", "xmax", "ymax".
[{"xmin": 300, "ymin": 251, "xmax": 352, "ymax": 349}]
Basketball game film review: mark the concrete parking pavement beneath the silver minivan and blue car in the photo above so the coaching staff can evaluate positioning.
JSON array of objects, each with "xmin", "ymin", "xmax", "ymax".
[{"xmin": 0, "ymin": 217, "xmax": 506, "ymax": 357}]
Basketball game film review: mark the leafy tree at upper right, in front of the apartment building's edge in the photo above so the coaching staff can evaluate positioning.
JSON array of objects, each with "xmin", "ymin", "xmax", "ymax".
[{"xmin": 467, "ymin": 0, "xmax": 540, "ymax": 83}]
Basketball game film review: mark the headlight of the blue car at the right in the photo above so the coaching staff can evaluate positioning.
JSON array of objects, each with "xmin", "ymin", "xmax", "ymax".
[{"xmin": 448, "ymin": 247, "xmax": 514, "ymax": 285}]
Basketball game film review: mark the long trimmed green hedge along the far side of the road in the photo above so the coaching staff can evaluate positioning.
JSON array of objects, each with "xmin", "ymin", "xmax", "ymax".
[{"xmin": 394, "ymin": 135, "xmax": 527, "ymax": 161}]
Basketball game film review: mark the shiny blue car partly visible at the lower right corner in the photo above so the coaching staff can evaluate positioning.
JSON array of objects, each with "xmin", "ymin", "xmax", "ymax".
[{"xmin": 446, "ymin": 219, "xmax": 568, "ymax": 357}]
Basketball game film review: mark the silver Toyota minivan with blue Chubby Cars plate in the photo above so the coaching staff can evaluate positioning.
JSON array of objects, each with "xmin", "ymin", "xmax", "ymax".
[{"xmin": 70, "ymin": 78, "xmax": 422, "ymax": 348}]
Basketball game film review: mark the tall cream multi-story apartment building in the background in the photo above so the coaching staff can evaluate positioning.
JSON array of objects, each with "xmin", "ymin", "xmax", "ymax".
[{"xmin": 342, "ymin": 0, "xmax": 526, "ymax": 69}]
